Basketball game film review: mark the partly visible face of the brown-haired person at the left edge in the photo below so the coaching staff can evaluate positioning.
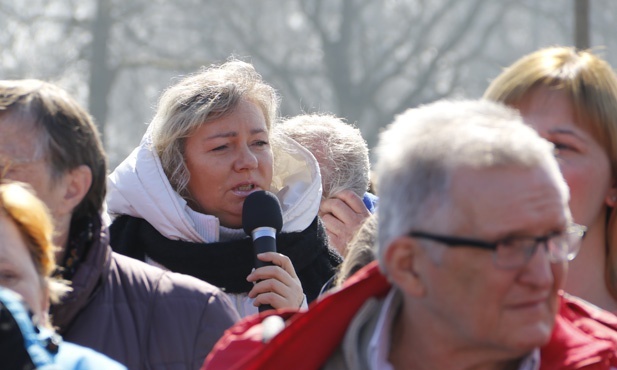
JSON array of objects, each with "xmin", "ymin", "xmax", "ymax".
[{"xmin": 0, "ymin": 115, "xmax": 64, "ymax": 218}]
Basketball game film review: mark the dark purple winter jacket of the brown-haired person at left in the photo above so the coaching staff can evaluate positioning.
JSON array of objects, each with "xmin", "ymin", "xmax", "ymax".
[{"xmin": 51, "ymin": 225, "xmax": 239, "ymax": 370}]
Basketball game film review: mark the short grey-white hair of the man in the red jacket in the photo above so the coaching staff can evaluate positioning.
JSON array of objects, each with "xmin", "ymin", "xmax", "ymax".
[{"xmin": 376, "ymin": 100, "xmax": 569, "ymax": 262}]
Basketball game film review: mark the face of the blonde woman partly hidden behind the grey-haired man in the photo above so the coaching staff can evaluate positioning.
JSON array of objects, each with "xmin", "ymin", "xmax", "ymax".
[{"xmin": 516, "ymin": 87, "xmax": 614, "ymax": 230}]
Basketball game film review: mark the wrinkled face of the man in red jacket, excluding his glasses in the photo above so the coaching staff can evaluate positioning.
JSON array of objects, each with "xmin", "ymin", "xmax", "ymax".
[{"xmin": 412, "ymin": 167, "xmax": 569, "ymax": 358}]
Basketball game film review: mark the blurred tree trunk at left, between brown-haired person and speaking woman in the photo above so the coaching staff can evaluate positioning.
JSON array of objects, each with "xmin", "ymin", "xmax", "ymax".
[{"xmin": 88, "ymin": 0, "xmax": 114, "ymax": 143}]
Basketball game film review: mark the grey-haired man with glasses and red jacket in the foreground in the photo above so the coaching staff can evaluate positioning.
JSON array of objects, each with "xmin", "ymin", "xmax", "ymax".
[{"xmin": 202, "ymin": 101, "xmax": 617, "ymax": 370}]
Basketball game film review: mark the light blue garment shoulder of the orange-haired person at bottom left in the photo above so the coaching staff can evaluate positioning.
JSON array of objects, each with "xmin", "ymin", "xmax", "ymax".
[{"xmin": 55, "ymin": 342, "xmax": 126, "ymax": 370}]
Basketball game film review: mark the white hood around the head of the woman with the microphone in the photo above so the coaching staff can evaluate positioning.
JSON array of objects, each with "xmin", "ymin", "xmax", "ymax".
[{"xmin": 106, "ymin": 130, "xmax": 322, "ymax": 243}]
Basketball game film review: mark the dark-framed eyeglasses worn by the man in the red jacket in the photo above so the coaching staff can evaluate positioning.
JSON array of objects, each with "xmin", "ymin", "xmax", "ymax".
[{"xmin": 407, "ymin": 223, "xmax": 587, "ymax": 269}]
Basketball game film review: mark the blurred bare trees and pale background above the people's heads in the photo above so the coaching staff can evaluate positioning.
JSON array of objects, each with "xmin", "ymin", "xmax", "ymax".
[{"xmin": 0, "ymin": 0, "xmax": 617, "ymax": 168}]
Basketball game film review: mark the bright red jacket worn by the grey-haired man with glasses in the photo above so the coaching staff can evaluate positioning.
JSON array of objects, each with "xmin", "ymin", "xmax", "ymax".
[{"xmin": 202, "ymin": 262, "xmax": 617, "ymax": 370}]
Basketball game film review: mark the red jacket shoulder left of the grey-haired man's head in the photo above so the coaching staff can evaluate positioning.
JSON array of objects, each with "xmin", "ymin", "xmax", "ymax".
[{"xmin": 202, "ymin": 261, "xmax": 384, "ymax": 370}]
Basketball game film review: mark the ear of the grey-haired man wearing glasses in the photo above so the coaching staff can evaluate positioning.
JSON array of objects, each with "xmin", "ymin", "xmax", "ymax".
[{"xmin": 384, "ymin": 236, "xmax": 426, "ymax": 297}]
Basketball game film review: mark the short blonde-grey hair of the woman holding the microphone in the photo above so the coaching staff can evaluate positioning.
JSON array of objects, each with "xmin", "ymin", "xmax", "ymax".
[{"xmin": 151, "ymin": 59, "xmax": 280, "ymax": 197}]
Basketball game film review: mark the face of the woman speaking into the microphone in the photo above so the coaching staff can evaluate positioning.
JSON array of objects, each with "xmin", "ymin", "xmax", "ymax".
[{"xmin": 185, "ymin": 100, "xmax": 273, "ymax": 228}]
